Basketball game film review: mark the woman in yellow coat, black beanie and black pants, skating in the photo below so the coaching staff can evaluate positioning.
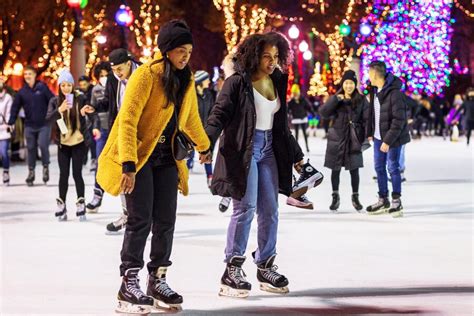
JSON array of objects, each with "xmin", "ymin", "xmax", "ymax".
[{"xmin": 97, "ymin": 20, "xmax": 210, "ymax": 313}]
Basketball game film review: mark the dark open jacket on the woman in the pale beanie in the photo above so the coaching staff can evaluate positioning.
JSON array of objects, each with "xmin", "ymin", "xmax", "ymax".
[{"xmin": 46, "ymin": 92, "xmax": 93, "ymax": 147}]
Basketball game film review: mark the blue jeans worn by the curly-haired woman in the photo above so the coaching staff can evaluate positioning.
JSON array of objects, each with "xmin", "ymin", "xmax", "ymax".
[{"xmin": 225, "ymin": 130, "xmax": 278, "ymax": 264}]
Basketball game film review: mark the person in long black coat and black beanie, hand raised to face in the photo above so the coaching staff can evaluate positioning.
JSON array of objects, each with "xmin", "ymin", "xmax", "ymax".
[{"xmin": 319, "ymin": 70, "xmax": 368, "ymax": 211}]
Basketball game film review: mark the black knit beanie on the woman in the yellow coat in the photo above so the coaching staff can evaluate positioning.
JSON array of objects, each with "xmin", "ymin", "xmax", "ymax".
[{"xmin": 158, "ymin": 20, "xmax": 193, "ymax": 54}]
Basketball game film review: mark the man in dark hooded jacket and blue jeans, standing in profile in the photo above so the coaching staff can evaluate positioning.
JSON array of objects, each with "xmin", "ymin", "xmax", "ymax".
[{"xmin": 367, "ymin": 61, "xmax": 410, "ymax": 217}]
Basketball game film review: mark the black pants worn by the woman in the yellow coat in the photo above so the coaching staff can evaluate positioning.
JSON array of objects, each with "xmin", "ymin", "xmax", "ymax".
[{"xmin": 120, "ymin": 162, "xmax": 178, "ymax": 276}]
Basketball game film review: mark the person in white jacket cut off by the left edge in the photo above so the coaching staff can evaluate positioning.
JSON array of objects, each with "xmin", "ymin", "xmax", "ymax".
[{"xmin": 0, "ymin": 78, "xmax": 13, "ymax": 185}]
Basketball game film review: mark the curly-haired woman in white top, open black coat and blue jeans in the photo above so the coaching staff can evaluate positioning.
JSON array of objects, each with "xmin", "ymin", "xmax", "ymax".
[{"xmin": 206, "ymin": 32, "xmax": 304, "ymax": 297}]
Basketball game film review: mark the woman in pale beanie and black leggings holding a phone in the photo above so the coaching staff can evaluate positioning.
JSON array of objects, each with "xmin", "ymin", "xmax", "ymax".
[{"xmin": 46, "ymin": 69, "xmax": 92, "ymax": 221}]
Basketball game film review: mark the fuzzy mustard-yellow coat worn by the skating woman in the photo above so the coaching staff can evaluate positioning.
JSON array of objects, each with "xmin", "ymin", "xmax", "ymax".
[{"xmin": 97, "ymin": 52, "xmax": 210, "ymax": 196}]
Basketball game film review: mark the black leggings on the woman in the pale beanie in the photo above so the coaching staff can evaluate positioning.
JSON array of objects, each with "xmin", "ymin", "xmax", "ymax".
[{"xmin": 58, "ymin": 142, "xmax": 86, "ymax": 202}]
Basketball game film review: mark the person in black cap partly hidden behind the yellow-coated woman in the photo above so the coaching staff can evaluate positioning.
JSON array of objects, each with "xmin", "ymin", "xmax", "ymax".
[{"xmin": 86, "ymin": 61, "xmax": 112, "ymax": 214}]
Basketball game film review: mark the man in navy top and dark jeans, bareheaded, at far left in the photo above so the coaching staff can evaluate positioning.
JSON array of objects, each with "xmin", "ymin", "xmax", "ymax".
[{"xmin": 8, "ymin": 66, "xmax": 54, "ymax": 187}]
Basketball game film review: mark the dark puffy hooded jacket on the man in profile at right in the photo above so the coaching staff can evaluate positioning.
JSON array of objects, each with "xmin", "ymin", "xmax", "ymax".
[{"xmin": 367, "ymin": 74, "xmax": 410, "ymax": 147}]
